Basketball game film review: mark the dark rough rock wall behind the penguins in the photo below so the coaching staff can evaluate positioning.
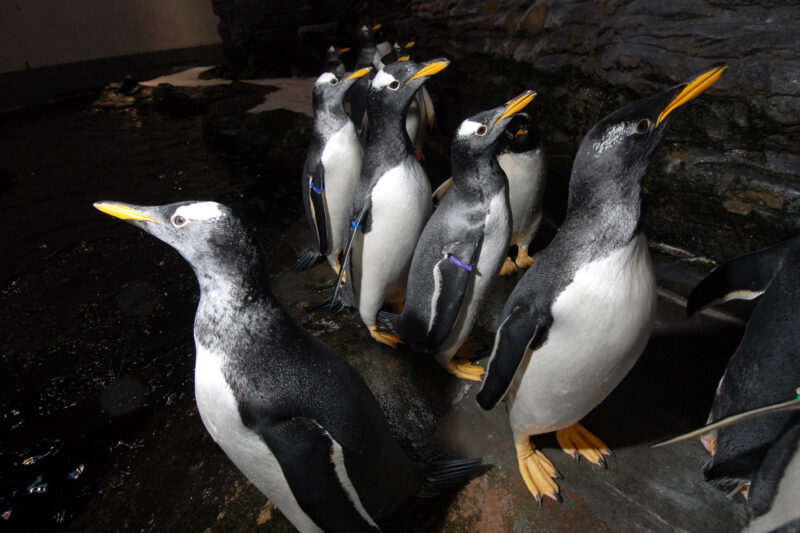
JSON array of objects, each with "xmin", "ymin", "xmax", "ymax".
[{"xmin": 213, "ymin": 0, "xmax": 800, "ymax": 261}]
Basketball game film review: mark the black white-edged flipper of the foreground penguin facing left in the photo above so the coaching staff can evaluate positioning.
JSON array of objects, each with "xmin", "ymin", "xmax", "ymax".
[{"xmin": 245, "ymin": 416, "xmax": 380, "ymax": 532}]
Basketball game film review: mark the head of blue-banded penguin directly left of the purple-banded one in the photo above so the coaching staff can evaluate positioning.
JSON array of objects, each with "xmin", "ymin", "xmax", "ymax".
[{"xmin": 368, "ymin": 57, "xmax": 450, "ymax": 117}]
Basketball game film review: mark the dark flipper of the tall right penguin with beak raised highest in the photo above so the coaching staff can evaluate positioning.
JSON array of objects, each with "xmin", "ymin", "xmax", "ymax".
[{"xmin": 476, "ymin": 307, "xmax": 553, "ymax": 411}]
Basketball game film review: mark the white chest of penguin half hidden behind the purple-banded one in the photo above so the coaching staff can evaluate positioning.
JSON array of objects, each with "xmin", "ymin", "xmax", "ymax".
[{"xmin": 497, "ymin": 143, "xmax": 544, "ymax": 239}]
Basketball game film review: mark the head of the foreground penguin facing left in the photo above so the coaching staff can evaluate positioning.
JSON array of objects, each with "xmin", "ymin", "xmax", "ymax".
[{"xmin": 94, "ymin": 197, "xmax": 260, "ymax": 277}]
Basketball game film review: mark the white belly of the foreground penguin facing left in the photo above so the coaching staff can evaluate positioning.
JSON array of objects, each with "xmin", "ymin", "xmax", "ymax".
[{"xmin": 194, "ymin": 340, "xmax": 322, "ymax": 532}]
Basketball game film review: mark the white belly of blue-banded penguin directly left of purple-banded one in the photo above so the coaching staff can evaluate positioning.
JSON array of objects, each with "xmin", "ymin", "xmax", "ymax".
[{"xmin": 352, "ymin": 158, "xmax": 433, "ymax": 327}]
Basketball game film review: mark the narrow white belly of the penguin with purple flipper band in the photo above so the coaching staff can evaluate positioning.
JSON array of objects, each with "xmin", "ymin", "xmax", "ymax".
[{"xmin": 438, "ymin": 191, "xmax": 511, "ymax": 366}]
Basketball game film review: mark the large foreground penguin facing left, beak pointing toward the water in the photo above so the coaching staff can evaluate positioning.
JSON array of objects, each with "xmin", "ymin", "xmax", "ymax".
[{"xmin": 95, "ymin": 202, "xmax": 480, "ymax": 532}]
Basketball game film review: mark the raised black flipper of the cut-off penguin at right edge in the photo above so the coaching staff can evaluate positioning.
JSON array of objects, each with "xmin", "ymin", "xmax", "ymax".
[{"xmin": 686, "ymin": 238, "xmax": 798, "ymax": 316}]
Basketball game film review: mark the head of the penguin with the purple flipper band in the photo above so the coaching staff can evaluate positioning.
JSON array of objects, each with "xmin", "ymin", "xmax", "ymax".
[{"xmin": 451, "ymin": 91, "xmax": 536, "ymax": 159}]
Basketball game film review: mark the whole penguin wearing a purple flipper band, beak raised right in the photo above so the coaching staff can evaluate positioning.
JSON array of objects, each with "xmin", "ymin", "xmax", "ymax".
[{"xmin": 378, "ymin": 91, "xmax": 536, "ymax": 381}]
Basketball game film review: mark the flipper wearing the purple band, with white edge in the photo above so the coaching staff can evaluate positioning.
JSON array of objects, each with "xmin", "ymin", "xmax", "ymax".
[{"xmin": 425, "ymin": 235, "xmax": 483, "ymax": 348}]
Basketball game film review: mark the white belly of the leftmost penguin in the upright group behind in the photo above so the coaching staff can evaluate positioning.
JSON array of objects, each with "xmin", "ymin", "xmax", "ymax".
[{"xmin": 321, "ymin": 121, "xmax": 364, "ymax": 266}]
